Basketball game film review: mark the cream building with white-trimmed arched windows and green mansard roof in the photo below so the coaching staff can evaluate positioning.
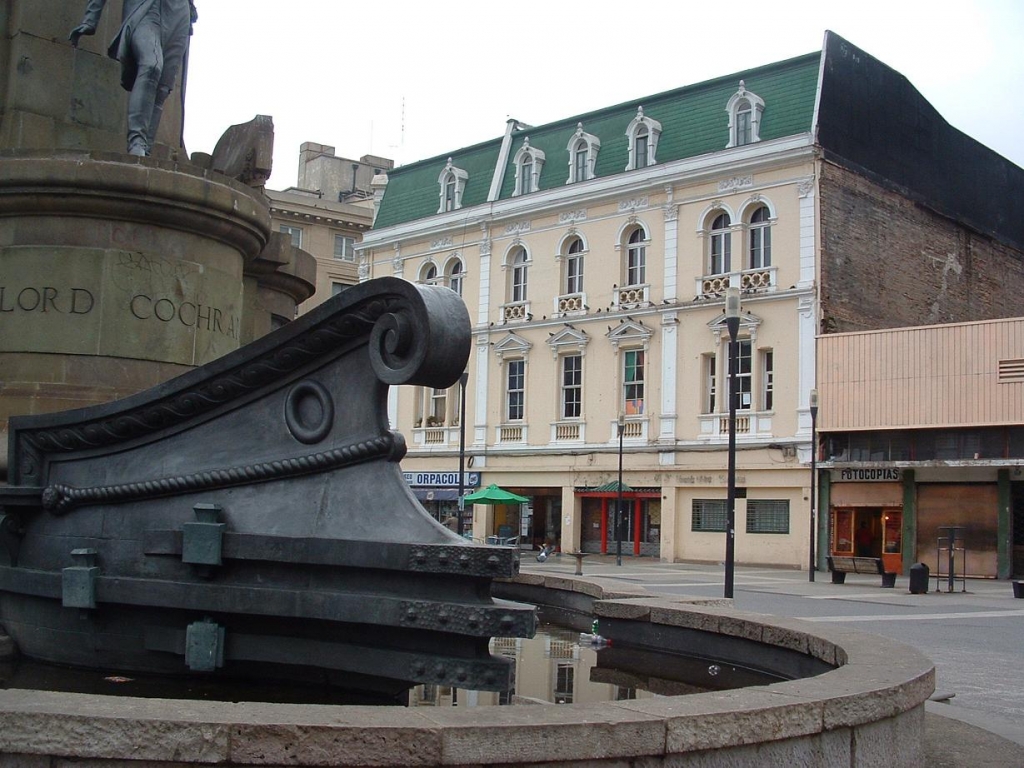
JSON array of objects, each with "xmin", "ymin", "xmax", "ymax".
[{"xmin": 360, "ymin": 33, "xmax": 1024, "ymax": 567}]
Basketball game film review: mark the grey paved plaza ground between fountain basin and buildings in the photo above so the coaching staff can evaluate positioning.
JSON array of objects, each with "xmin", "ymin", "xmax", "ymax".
[{"xmin": 522, "ymin": 552, "xmax": 1024, "ymax": 768}]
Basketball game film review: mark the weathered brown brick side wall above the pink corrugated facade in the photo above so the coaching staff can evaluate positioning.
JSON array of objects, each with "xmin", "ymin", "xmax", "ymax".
[{"xmin": 819, "ymin": 162, "xmax": 1024, "ymax": 333}]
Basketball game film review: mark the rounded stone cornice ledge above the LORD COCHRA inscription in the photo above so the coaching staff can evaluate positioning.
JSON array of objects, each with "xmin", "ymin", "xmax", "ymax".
[{"xmin": 0, "ymin": 151, "xmax": 270, "ymax": 260}]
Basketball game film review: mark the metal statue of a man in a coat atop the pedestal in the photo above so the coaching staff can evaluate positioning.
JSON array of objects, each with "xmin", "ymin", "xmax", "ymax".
[{"xmin": 69, "ymin": 0, "xmax": 197, "ymax": 156}]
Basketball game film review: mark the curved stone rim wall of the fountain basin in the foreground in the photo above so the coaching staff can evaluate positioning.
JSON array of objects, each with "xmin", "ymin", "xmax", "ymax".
[{"xmin": 0, "ymin": 574, "xmax": 935, "ymax": 768}]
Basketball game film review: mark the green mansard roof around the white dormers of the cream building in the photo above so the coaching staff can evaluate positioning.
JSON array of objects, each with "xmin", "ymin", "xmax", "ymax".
[{"xmin": 374, "ymin": 52, "xmax": 821, "ymax": 229}]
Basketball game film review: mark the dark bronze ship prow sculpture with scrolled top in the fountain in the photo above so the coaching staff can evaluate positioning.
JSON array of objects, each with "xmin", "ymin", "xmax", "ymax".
[{"xmin": 0, "ymin": 278, "xmax": 537, "ymax": 690}]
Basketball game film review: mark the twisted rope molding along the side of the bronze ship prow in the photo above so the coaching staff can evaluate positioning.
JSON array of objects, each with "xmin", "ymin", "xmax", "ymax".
[{"xmin": 43, "ymin": 432, "xmax": 406, "ymax": 515}]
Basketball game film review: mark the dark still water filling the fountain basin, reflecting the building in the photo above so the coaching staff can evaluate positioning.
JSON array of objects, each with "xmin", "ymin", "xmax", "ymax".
[{"xmin": 0, "ymin": 625, "xmax": 780, "ymax": 707}]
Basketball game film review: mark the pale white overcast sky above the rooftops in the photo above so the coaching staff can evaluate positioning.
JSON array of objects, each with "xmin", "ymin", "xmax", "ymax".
[{"xmin": 185, "ymin": 0, "xmax": 1024, "ymax": 189}]
